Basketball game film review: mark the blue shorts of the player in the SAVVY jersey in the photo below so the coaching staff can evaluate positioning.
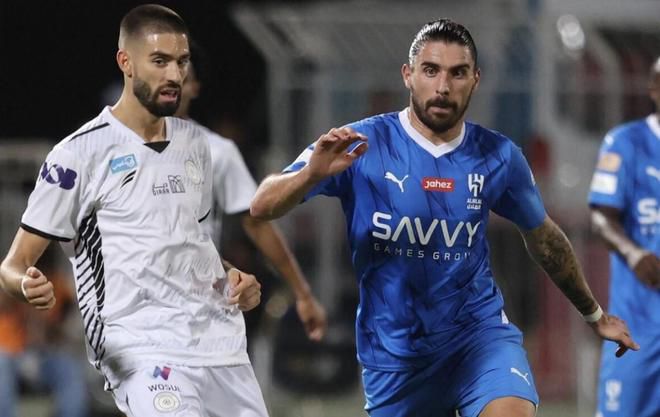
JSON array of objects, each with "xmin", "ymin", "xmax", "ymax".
[{"xmin": 362, "ymin": 321, "xmax": 539, "ymax": 417}]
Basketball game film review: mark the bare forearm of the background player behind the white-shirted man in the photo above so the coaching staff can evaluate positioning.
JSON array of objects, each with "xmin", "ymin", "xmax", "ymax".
[{"xmin": 242, "ymin": 215, "xmax": 311, "ymax": 299}]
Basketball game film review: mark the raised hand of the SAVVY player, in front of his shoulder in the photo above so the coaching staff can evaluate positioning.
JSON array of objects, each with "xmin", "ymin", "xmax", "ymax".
[{"xmin": 307, "ymin": 127, "xmax": 367, "ymax": 179}]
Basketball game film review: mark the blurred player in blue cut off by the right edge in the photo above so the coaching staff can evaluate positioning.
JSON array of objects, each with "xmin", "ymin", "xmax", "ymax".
[{"xmin": 589, "ymin": 58, "xmax": 660, "ymax": 417}]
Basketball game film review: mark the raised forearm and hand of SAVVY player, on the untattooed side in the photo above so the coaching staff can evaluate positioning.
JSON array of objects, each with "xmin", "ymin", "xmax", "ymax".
[{"xmin": 250, "ymin": 127, "xmax": 367, "ymax": 220}]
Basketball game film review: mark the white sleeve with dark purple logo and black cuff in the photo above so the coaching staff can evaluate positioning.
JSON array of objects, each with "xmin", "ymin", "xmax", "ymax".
[{"xmin": 21, "ymin": 146, "xmax": 86, "ymax": 241}]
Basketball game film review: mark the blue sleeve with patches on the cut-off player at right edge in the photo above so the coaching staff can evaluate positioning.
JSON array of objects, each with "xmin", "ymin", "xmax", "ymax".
[{"xmin": 589, "ymin": 133, "xmax": 632, "ymax": 209}]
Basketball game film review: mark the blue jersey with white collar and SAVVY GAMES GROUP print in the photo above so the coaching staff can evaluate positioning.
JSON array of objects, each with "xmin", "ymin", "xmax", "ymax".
[{"xmin": 285, "ymin": 110, "xmax": 545, "ymax": 370}]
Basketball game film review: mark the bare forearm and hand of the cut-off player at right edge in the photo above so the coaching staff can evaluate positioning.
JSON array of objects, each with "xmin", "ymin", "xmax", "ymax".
[{"xmin": 591, "ymin": 206, "xmax": 660, "ymax": 288}]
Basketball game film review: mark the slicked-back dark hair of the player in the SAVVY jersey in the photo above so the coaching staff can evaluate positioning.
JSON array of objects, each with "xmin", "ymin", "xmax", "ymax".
[{"xmin": 408, "ymin": 19, "xmax": 478, "ymax": 68}]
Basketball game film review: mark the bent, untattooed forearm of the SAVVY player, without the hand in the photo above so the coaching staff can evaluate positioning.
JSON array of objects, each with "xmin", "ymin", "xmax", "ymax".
[{"xmin": 250, "ymin": 168, "xmax": 318, "ymax": 220}]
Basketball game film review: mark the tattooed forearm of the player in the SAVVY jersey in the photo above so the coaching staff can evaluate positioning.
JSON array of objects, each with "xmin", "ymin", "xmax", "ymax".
[{"xmin": 523, "ymin": 217, "xmax": 598, "ymax": 315}]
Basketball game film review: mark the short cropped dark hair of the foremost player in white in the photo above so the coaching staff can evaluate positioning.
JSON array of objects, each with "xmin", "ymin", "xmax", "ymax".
[{"xmin": 119, "ymin": 4, "xmax": 188, "ymax": 44}]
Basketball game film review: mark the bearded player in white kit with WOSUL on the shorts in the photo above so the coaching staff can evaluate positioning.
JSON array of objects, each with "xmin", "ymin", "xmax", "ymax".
[{"xmin": 0, "ymin": 5, "xmax": 267, "ymax": 417}]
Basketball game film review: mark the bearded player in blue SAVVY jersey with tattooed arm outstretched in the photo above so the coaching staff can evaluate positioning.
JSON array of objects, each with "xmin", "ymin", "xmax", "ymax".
[{"xmin": 251, "ymin": 19, "xmax": 638, "ymax": 417}]
